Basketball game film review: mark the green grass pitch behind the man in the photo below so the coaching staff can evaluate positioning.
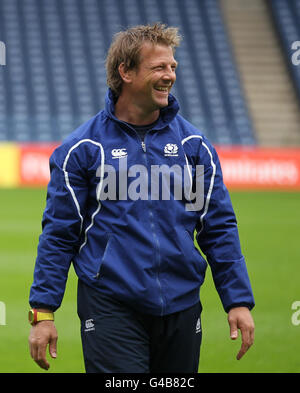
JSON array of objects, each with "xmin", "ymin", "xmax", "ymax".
[{"xmin": 0, "ymin": 189, "xmax": 300, "ymax": 373}]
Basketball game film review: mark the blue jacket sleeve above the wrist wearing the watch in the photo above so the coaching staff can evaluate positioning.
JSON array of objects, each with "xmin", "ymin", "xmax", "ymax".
[{"xmin": 29, "ymin": 142, "xmax": 87, "ymax": 311}]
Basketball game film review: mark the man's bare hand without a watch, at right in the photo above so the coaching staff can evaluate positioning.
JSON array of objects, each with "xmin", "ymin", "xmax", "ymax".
[{"xmin": 228, "ymin": 307, "xmax": 254, "ymax": 360}]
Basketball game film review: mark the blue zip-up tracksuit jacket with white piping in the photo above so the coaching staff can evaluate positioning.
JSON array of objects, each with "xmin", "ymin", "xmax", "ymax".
[{"xmin": 29, "ymin": 90, "xmax": 254, "ymax": 315}]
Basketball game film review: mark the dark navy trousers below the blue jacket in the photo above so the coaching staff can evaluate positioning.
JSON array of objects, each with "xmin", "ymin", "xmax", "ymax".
[{"xmin": 78, "ymin": 280, "xmax": 202, "ymax": 373}]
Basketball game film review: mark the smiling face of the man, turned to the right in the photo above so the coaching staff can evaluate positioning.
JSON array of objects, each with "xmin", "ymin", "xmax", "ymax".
[{"xmin": 130, "ymin": 43, "xmax": 177, "ymax": 112}]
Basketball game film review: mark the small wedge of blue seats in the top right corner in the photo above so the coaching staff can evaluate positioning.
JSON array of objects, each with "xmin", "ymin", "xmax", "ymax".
[{"xmin": 269, "ymin": 0, "xmax": 300, "ymax": 103}]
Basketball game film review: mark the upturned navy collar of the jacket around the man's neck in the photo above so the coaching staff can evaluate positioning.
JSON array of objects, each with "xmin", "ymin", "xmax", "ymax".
[{"xmin": 105, "ymin": 88, "xmax": 179, "ymax": 129}]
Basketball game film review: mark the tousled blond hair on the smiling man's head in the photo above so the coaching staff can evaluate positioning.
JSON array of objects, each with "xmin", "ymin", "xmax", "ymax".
[{"xmin": 106, "ymin": 23, "xmax": 181, "ymax": 96}]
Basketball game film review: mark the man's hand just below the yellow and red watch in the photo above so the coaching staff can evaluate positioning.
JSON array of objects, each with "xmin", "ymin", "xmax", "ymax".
[{"xmin": 29, "ymin": 321, "xmax": 58, "ymax": 370}]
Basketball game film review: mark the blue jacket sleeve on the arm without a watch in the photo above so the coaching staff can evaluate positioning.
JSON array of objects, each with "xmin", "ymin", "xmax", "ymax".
[{"xmin": 196, "ymin": 139, "xmax": 254, "ymax": 312}]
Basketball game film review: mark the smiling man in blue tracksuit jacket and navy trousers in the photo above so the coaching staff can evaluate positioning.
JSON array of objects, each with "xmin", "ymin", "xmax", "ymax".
[{"xmin": 29, "ymin": 24, "xmax": 254, "ymax": 373}]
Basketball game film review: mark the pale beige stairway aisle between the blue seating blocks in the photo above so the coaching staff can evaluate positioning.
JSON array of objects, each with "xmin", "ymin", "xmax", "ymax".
[{"xmin": 220, "ymin": 0, "xmax": 300, "ymax": 147}]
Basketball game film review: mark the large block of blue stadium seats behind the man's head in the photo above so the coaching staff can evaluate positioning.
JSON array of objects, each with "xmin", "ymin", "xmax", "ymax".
[{"xmin": 0, "ymin": 0, "xmax": 255, "ymax": 145}]
